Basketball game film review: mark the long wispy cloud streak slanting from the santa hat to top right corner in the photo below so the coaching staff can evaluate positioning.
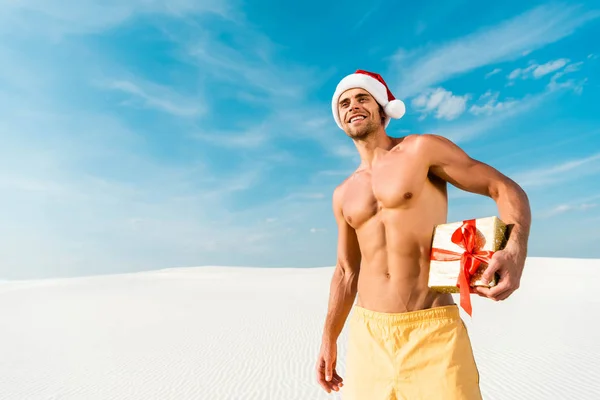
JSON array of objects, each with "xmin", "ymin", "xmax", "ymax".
[{"xmin": 390, "ymin": 4, "xmax": 600, "ymax": 98}]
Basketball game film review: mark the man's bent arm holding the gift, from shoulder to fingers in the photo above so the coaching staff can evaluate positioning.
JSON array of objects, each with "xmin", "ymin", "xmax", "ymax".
[{"xmin": 419, "ymin": 135, "xmax": 531, "ymax": 300}]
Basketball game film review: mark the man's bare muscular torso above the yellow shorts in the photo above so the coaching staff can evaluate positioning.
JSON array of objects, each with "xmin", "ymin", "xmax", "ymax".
[{"xmin": 341, "ymin": 137, "xmax": 454, "ymax": 313}]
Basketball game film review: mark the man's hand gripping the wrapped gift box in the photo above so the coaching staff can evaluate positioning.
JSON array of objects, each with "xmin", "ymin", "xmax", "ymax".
[{"xmin": 474, "ymin": 249, "xmax": 525, "ymax": 301}]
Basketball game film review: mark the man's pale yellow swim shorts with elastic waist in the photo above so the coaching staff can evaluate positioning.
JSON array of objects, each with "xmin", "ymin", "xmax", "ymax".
[{"xmin": 341, "ymin": 305, "xmax": 482, "ymax": 400}]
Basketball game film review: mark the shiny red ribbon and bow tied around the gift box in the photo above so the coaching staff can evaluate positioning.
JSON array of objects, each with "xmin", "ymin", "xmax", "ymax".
[{"xmin": 431, "ymin": 219, "xmax": 494, "ymax": 316}]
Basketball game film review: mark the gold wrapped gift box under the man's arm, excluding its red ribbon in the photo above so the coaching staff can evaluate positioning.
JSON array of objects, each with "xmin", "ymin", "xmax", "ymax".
[{"xmin": 429, "ymin": 216, "xmax": 507, "ymax": 293}]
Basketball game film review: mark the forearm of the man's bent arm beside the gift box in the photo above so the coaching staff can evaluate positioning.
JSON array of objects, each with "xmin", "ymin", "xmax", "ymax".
[{"xmin": 494, "ymin": 180, "xmax": 531, "ymax": 261}]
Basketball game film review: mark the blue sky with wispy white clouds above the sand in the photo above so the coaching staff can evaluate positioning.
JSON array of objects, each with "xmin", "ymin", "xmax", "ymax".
[{"xmin": 0, "ymin": 0, "xmax": 600, "ymax": 279}]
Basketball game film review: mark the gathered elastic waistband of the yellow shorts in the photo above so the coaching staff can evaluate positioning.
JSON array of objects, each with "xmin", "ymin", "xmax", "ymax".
[{"xmin": 353, "ymin": 304, "xmax": 460, "ymax": 325}]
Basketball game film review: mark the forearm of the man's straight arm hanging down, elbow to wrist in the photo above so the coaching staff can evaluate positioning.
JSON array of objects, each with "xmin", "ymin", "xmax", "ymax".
[{"xmin": 323, "ymin": 266, "xmax": 358, "ymax": 342}]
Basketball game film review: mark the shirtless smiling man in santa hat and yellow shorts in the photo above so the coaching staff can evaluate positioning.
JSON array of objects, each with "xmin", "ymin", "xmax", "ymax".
[{"xmin": 316, "ymin": 70, "xmax": 531, "ymax": 400}]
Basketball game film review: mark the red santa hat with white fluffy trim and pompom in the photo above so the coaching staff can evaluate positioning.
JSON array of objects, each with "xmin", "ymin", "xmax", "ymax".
[{"xmin": 331, "ymin": 69, "xmax": 406, "ymax": 129}]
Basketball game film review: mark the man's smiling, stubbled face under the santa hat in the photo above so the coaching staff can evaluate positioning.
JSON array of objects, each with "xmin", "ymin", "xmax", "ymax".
[{"xmin": 338, "ymin": 88, "xmax": 383, "ymax": 139}]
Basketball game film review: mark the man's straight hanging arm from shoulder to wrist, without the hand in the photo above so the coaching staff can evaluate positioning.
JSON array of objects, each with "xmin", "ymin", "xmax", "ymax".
[{"xmin": 323, "ymin": 187, "xmax": 361, "ymax": 343}]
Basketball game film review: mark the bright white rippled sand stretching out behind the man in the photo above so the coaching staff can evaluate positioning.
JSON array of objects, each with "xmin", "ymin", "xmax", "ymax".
[{"xmin": 0, "ymin": 258, "xmax": 600, "ymax": 400}]
